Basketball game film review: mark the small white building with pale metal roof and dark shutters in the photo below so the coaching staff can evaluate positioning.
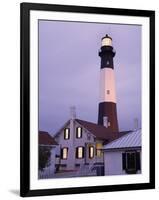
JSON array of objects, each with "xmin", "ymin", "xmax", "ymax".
[{"xmin": 104, "ymin": 129, "xmax": 142, "ymax": 175}]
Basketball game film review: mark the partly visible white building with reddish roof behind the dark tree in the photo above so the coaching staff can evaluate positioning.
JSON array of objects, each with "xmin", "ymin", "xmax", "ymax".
[{"xmin": 39, "ymin": 131, "xmax": 58, "ymax": 178}]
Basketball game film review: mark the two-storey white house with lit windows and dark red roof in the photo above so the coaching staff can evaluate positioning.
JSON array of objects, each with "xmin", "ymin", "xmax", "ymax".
[{"xmin": 54, "ymin": 108, "xmax": 129, "ymax": 177}]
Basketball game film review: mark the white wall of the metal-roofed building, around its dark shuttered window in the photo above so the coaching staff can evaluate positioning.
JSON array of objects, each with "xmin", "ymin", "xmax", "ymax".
[{"xmin": 104, "ymin": 150, "xmax": 142, "ymax": 175}]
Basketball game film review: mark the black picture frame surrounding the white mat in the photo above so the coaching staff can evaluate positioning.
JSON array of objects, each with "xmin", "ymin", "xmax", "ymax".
[{"xmin": 20, "ymin": 3, "xmax": 155, "ymax": 197}]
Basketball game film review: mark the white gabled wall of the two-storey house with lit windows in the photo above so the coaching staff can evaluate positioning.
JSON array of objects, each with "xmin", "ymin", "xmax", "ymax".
[{"xmin": 55, "ymin": 120, "xmax": 103, "ymax": 170}]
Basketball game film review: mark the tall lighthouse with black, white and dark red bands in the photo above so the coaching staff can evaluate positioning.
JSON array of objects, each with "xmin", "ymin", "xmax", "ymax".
[{"xmin": 98, "ymin": 34, "xmax": 119, "ymax": 132}]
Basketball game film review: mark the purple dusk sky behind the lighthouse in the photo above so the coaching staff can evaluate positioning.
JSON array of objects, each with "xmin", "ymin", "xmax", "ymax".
[{"xmin": 39, "ymin": 20, "xmax": 142, "ymax": 135}]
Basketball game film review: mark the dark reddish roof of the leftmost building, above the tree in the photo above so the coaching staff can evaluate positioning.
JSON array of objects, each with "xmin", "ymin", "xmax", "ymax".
[{"xmin": 39, "ymin": 131, "xmax": 58, "ymax": 145}]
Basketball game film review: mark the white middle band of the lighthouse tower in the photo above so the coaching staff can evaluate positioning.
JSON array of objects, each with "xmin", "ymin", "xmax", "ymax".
[{"xmin": 100, "ymin": 68, "xmax": 116, "ymax": 103}]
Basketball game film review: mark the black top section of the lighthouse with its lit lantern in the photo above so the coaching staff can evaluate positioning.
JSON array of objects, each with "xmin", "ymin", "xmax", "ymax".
[{"xmin": 99, "ymin": 34, "xmax": 115, "ymax": 69}]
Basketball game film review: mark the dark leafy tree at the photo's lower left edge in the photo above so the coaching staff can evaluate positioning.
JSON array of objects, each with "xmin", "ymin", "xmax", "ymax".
[{"xmin": 39, "ymin": 146, "xmax": 51, "ymax": 171}]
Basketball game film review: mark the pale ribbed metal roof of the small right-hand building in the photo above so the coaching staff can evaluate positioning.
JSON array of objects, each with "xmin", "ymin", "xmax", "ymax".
[{"xmin": 104, "ymin": 129, "xmax": 141, "ymax": 149}]
